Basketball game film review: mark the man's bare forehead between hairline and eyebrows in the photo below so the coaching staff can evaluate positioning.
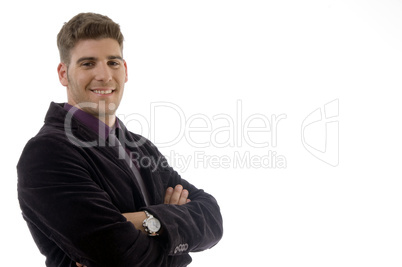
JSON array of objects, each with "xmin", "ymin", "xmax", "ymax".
[{"xmin": 71, "ymin": 38, "xmax": 122, "ymax": 61}]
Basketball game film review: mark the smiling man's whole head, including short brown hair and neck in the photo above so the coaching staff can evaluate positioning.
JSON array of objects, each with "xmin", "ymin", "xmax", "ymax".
[{"xmin": 57, "ymin": 13, "xmax": 127, "ymax": 126}]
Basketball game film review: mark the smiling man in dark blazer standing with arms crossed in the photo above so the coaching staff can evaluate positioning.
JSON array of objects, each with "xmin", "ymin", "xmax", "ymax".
[{"xmin": 17, "ymin": 13, "xmax": 223, "ymax": 267}]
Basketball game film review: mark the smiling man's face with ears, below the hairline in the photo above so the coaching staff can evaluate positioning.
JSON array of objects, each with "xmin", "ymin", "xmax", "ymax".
[{"xmin": 58, "ymin": 38, "xmax": 127, "ymax": 120}]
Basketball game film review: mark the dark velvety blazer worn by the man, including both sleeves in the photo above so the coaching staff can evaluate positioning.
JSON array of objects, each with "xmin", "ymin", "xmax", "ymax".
[{"xmin": 17, "ymin": 103, "xmax": 223, "ymax": 267}]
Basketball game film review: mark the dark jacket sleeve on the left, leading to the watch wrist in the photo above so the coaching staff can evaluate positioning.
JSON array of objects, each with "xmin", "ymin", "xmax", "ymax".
[{"xmin": 17, "ymin": 138, "xmax": 189, "ymax": 267}]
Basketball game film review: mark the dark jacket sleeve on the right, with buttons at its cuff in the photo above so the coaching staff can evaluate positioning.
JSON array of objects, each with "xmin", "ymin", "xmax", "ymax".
[{"xmin": 139, "ymin": 138, "xmax": 223, "ymax": 256}]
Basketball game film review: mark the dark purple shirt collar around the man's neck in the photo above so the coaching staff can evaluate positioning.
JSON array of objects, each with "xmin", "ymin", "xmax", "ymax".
[{"xmin": 64, "ymin": 103, "xmax": 121, "ymax": 140}]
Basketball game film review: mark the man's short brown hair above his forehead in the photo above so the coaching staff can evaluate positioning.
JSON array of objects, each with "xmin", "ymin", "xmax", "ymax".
[{"xmin": 57, "ymin": 13, "xmax": 124, "ymax": 64}]
